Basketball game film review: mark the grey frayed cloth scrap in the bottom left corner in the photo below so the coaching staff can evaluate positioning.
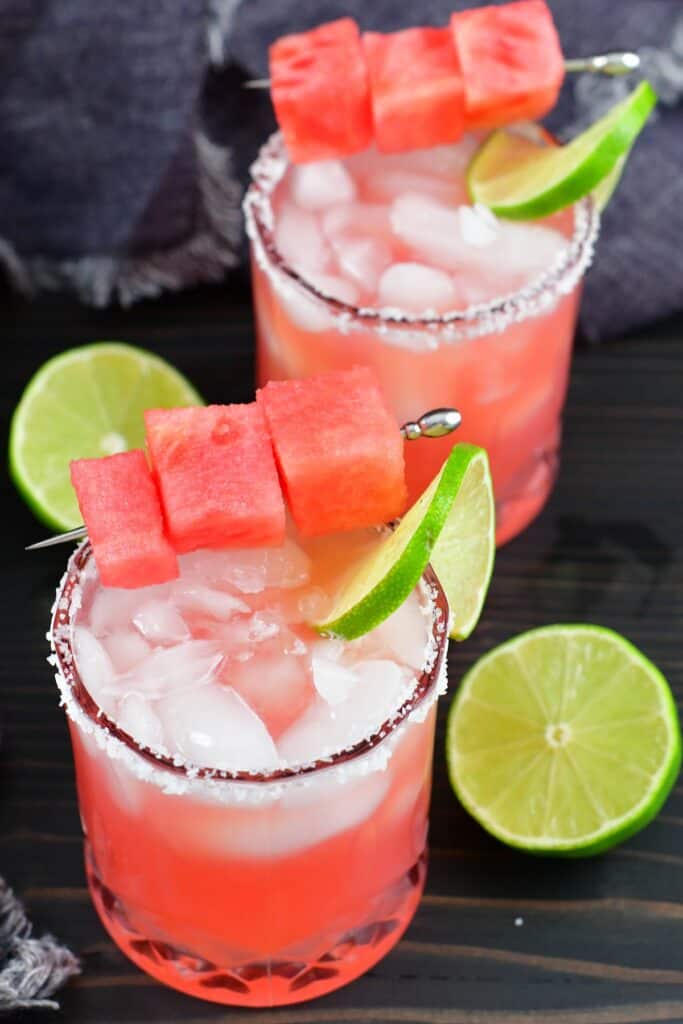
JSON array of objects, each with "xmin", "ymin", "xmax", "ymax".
[{"xmin": 0, "ymin": 879, "xmax": 81, "ymax": 1014}]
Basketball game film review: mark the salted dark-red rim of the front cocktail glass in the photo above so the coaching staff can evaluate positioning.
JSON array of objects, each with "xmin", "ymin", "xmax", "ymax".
[{"xmin": 48, "ymin": 540, "xmax": 449, "ymax": 785}]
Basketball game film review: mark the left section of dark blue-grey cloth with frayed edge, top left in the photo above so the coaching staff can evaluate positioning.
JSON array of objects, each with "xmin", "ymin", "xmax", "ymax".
[{"xmin": 0, "ymin": 0, "xmax": 240, "ymax": 304}]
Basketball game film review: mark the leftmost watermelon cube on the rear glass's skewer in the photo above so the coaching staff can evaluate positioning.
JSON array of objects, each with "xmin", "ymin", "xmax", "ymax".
[{"xmin": 269, "ymin": 17, "xmax": 373, "ymax": 164}]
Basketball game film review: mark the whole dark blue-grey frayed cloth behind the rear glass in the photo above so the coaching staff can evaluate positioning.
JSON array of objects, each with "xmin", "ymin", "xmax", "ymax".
[{"xmin": 0, "ymin": 0, "xmax": 683, "ymax": 339}]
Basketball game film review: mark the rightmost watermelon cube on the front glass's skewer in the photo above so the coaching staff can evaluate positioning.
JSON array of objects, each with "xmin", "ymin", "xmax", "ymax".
[{"xmin": 257, "ymin": 367, "xmax": 407, "ymax": 537}]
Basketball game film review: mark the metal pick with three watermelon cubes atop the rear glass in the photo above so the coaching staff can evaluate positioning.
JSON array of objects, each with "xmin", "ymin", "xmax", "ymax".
[{"xmin": 253, "ymin": 0, "xmax": 640, "ymax": 164}]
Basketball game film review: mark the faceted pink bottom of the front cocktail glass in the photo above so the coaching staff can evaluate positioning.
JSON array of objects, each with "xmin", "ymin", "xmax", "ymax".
[{"xmin": 85, "ymin": 841, "xmax": 427, "ymax": 1007}]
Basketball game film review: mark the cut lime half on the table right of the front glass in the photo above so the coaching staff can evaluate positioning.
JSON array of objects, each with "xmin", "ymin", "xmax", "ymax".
[{"xmin": 446, "ymin": 625, "xmax": 681, "ymax": 856}]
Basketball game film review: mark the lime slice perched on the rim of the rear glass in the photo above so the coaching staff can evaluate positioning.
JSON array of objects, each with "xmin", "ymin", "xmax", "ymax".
[{"xmin": 467, "ymin": 82, "xmax": 656, "ymax": 220}]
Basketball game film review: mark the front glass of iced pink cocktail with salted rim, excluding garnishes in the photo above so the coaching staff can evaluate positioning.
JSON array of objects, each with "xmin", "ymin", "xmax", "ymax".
[{"xmin": 52, "ymin": 534, "xmax": 447, "ymax": 1007}]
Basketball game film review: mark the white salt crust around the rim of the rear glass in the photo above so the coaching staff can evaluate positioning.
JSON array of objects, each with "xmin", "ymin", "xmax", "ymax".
[{"xmin": 243, "ymin": 126, "xmax": 600, "ymax": 349}]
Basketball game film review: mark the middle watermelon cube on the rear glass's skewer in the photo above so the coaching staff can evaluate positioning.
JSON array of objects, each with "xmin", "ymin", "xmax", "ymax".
[{"xmin": 362, "ymin": 28, "xmax": 465, "ymax": 153}]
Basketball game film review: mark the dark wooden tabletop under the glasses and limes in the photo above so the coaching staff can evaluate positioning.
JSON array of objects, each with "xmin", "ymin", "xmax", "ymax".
[{"xmin": 0, "ymin": 281, "xmax": 683, "ymax": 1024}]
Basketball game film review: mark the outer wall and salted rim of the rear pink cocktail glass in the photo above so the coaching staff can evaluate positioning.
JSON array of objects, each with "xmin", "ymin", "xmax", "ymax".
[{"xmin": 245, "ymin": 135, "xmax": 599, "ymax": 544}]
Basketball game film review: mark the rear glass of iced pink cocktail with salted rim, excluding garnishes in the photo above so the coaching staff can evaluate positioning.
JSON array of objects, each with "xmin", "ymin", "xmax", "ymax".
[{"xmin": 245, "ymin": 136, "xmax": 598, "ymax": 543}]
